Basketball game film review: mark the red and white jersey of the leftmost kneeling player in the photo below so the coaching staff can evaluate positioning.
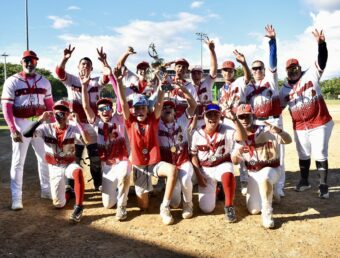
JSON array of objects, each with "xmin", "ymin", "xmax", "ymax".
[{"xmin": 34, "ymin": 123, "xmax": 81, "ymax": 166}]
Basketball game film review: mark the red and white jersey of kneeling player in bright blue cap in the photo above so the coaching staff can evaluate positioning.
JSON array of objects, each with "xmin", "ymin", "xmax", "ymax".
[{"xmin": 190, "ymin": 124, "xmax": 235, "ymax": 167}]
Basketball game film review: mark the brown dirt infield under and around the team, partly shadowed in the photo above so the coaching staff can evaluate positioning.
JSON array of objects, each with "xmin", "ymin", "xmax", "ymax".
[{"xmin": 0, "ymin": 104, "xmax": 340, "ymax": 257}]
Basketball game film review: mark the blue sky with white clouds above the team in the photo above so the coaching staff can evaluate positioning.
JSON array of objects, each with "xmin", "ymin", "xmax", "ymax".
[{"xmin": 0, "ymin": 0, "xmax": 340, "ymax": 79}]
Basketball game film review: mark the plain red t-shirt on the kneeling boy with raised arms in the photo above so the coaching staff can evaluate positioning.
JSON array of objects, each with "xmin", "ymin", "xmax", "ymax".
[{"xmin": 125, "ymin": 113, "xmax": 161, "ymax": 166}]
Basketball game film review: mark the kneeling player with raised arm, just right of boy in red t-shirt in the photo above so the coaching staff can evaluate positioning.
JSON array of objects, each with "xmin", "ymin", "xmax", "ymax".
[{"xmin": 158, "ymin": 85, "xmax": 197, "ymax": 219}]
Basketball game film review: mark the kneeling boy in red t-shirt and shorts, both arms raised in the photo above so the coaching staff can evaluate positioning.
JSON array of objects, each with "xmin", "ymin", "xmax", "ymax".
[{"xmin": 117, "ymin": 67, "xmax": 177, "ymax": 225}]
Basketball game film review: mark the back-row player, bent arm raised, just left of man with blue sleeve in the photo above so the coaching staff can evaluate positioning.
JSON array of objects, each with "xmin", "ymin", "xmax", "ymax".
[{"xmin": 218, "ymin": 49, "xmax": 251, "ymax": 195}]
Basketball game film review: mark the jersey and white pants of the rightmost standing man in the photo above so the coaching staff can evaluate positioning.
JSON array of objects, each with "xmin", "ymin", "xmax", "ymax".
[{"xmin": 280, "ymin": 62, "xmax": 334, "ymax": 161}]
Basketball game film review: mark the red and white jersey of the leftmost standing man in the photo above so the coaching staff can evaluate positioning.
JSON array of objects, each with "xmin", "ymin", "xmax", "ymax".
[{"xmin": 1, "ymin": 72, "xmax": 52, "ymax": 118}]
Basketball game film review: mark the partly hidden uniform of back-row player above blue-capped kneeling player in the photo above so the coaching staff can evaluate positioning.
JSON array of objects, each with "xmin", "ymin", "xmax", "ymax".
[{"xmin": 194, "ymin": 74, "xmax": 215, "ymax": 128}]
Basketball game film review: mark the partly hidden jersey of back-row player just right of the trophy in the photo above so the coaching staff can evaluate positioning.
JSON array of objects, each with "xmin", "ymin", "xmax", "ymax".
[{"xmin": 165, "ymin": 80, "xmax": 198, "ymax": 117}]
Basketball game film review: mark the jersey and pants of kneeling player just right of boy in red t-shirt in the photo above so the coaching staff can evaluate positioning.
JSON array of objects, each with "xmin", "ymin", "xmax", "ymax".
[{"xmin": 158, "ymin": 112, "xmax": 193, "ymax": 207}]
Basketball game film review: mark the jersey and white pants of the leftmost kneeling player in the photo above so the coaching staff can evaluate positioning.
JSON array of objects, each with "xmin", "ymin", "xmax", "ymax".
[{"xmin": 34, "ymin": 123, "xmax": 81, "ymax": 207}]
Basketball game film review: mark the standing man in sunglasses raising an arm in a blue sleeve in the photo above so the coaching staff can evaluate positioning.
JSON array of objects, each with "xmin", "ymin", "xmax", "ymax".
[{"xmin": 245, "ymin": 25, "xmax": 285, "ymax": 197}]
